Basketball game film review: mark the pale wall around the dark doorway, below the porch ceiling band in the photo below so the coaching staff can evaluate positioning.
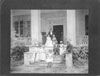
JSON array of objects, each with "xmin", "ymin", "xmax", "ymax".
[{"xmin": 41, "ymin": 17, "xmax": 67, "ymax": 42}]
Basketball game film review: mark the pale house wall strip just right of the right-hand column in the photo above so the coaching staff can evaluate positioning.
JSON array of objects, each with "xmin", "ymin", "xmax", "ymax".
[{"xmin": 76, "ymin": 10, "xmax": 89, "ymax": 44}]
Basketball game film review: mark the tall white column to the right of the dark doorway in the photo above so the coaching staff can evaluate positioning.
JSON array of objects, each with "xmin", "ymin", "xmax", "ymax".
[{"xmin": 67, "ymin": 10, "xmax": 76, "ymax": 45}]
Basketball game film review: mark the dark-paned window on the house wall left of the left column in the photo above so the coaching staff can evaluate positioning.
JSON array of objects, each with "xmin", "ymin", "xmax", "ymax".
[{"xmin": 14, "ymin": 16, "xmax": 31, "ymax": 38}]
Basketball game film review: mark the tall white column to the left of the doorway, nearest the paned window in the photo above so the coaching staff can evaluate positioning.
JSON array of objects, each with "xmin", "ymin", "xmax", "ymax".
[{"xmin": 31, "ymin": 10, "xmax": 41, "ymax": 42}]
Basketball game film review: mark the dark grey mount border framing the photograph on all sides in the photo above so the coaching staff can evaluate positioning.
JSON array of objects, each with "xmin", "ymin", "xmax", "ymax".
[{"xmin": 0, "ymin": 0, "xmax": 100, "ymax": 76}]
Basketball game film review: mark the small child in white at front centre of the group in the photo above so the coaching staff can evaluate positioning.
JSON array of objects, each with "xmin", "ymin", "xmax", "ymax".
[{"xmin": 46, "ymin": 49, "xmax": 53, "ymax": 67}]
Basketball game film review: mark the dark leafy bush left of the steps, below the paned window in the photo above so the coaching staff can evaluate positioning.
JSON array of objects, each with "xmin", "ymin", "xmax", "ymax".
[{"xmin": 11, "ymin": 46, "xmax": 29, "ymax": 61}]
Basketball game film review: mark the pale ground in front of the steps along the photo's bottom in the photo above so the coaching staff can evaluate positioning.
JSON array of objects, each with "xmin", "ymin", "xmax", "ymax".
[{"xmin": 11, "ymin": 55, "xmax": 88, "ymax": 74}]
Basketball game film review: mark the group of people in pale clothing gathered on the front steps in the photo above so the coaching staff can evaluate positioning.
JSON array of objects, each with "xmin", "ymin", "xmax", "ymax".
[{"xmin": 32, "ymin": 29, "xmax": 73, "ymax": 67}]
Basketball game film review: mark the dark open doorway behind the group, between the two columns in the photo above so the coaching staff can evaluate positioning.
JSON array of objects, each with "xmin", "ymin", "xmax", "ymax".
[{"xmin": 53, "ymin": 25, "xmax": 63, "ymax": 43}]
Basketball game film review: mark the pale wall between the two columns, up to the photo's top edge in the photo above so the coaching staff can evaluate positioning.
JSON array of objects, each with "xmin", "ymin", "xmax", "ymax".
[{"xmin": 41, "ymin": 10, "xmax": 67, "ymax": 42}]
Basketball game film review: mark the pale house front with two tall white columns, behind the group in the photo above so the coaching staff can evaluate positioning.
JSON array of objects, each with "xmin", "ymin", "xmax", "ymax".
[{"xmin": 11, "ymin": 9, "xmax": 89, "ymax": 46}]
